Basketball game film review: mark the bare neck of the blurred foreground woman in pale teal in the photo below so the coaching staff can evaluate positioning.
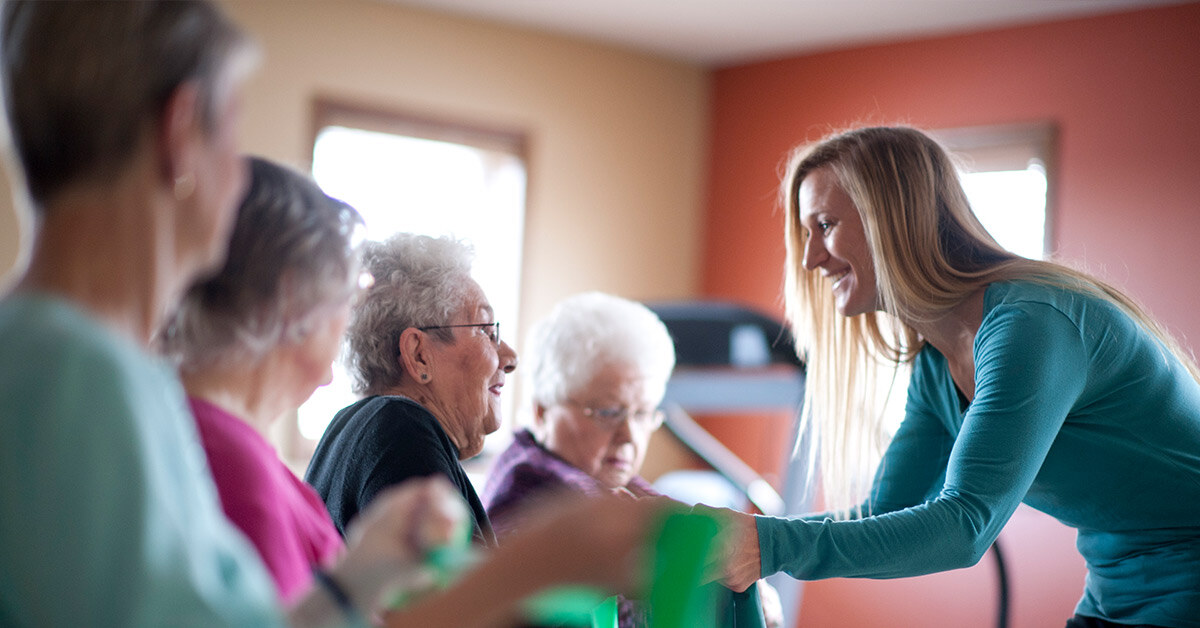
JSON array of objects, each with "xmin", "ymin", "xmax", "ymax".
[{"xmin": 18, "ymin": 174, "xmax": 191, "ymax": 347}]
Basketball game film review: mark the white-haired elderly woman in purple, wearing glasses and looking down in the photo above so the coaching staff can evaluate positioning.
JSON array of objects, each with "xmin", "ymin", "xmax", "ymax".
[{"xmin": 484, "ymin": 292, "xmax": 674, "ymax": 538}]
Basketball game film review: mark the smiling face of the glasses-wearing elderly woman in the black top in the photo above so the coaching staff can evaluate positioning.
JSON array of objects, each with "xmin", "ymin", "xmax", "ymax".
[{"xmin": 427, "ymin": 277, "xmax": 517, "ymax": 460}]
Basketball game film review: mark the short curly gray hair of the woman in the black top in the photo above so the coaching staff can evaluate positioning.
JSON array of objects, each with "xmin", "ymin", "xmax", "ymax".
[{"xmin": 346, "ymin": 233, "xmax": 474, "ymax": 395}]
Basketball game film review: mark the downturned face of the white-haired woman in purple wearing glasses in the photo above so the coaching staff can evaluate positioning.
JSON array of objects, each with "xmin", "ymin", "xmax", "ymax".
[{"xmin": 536, "ymin": 364, "xmax": 661, "ymax": 489}]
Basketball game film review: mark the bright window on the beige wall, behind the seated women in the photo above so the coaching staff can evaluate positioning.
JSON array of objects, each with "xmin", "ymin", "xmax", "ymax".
[{"xmin": 299, "ymin": 102, "xmax": 526, "ymax": 439}]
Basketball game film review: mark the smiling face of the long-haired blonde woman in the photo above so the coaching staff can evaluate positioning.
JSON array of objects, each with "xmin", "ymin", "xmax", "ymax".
[{"xmin": 798, "ymin": 167, "xmax": 880, "ymax": 316}]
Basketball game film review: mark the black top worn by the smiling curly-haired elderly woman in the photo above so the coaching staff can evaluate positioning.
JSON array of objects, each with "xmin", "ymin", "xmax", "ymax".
[{"xmin": 305, "ymin": 395, "xmax": 496, "ymax": 546}]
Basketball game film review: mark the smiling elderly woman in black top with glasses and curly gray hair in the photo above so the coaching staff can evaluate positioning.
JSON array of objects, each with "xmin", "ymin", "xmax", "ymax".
[{"xmin": 305, "ymin": 233, "xmax": 517, "ymax": 546}]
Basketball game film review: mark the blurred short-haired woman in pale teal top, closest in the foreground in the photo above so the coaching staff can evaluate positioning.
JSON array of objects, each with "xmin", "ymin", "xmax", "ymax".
[{"xmin": 0, "ymin": 0, "xmax": 458, "ymax": 627}]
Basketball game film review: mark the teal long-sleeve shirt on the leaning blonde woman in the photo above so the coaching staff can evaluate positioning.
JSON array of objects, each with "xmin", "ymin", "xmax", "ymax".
[{"xmin": 757, "ymin": 282, "xmax": 1200, "ymax": 627}]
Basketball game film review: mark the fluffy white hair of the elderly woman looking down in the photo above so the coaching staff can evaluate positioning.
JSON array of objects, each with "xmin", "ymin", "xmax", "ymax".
[{"xmin": 524, "ymin": 292, "xmax": 676, "ymax": 406}]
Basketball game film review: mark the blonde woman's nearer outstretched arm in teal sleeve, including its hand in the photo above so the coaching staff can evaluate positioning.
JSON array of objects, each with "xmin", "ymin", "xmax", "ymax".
[{"xmin": 726, "ymin": 303, "xmax": 1087, "ymax": 588}]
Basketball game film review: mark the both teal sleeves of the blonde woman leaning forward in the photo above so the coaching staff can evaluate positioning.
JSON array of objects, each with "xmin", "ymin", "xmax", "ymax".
[{"xmin": 757, "ymin": 300, "xmax": 1086, "ymax": 579}]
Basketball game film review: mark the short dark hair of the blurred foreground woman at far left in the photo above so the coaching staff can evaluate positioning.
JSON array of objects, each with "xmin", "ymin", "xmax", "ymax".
[{"xmin": 0, "ymin": 0, "xmax": 258, "ymax": 211}]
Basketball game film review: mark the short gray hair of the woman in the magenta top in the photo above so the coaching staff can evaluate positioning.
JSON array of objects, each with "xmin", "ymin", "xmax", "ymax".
[{"xmin": 161, "ymin": 157, "xmax": 362, "ymax": 371}]
